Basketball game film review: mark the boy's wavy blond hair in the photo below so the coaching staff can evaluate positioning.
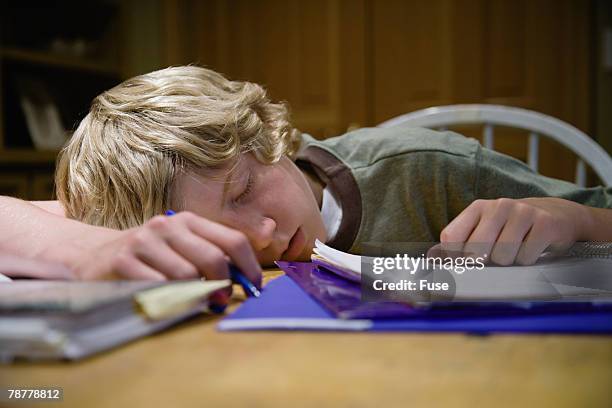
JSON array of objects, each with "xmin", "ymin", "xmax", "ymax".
[{"xmin": 55, "ymin": 66, "xmax": 300, "ymax": 229}]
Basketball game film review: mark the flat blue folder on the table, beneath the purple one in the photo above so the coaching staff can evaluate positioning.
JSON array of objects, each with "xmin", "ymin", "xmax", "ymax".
[{"xmin": 218, "ymin": 270, "xmax": 612, "ymax": 334}]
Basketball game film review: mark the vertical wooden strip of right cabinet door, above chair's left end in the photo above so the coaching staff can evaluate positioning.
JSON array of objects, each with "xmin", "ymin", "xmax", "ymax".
[{"xmin": 371, "ymin": 0, "xmax": 452, "ymax": 123}]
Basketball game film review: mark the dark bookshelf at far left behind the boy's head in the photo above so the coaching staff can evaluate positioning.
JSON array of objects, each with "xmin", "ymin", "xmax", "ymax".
[{"xmin": 0, "ymin": 0, "xmax": 124, "ymax": 200}]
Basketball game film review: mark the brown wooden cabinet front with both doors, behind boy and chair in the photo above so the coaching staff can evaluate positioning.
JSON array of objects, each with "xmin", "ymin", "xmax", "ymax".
[{"xmin": 164, "ymin": 0, "xmax": 592, "ymax": 179}]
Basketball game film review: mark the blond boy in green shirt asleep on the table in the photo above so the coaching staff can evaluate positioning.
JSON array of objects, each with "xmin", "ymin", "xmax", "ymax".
[{"xmin": 0, "ymin": 66, "xmax": 612, "ymax": 284}]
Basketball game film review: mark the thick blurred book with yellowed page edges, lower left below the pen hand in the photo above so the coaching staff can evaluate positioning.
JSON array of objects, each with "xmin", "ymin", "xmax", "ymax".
[{"xmin": 0, "ymin": 280, "xmax": 231, "ymax": 362}]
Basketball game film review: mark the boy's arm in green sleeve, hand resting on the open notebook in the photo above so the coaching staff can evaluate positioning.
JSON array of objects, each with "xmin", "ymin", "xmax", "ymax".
[{"xmin": 440, "ymin": 148, "xmax": 612, "ymax": 265}]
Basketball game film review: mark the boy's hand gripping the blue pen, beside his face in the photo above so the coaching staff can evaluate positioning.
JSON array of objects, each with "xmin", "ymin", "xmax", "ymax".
[{"xmin": 61, "ymin": 212, "xmax": 261, "ymax": 287}]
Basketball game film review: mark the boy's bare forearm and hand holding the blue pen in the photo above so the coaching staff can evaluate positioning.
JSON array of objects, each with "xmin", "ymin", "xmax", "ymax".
[{"xmin": 0, "ymin": 197, "xmax": 261, "ymax": 285}]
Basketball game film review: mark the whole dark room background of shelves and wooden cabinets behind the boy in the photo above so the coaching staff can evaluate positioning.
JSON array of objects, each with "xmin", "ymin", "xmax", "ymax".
[{"xmin": 0, "ymin": 0, "xmax": 612, "ymax": 199}]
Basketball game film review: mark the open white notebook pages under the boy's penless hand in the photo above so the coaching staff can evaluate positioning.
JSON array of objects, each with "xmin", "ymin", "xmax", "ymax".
[{"xmin": 312, "ymin": 241, "xmax": 612, "ymax": 301}]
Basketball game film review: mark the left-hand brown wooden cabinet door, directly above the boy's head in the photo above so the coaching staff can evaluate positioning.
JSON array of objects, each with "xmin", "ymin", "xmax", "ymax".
[{"xmin": 164, "ymin": 0, "xmax": 366, "ymax": 137}]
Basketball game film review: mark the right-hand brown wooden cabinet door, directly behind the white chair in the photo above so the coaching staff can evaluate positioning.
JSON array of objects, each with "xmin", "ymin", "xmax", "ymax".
[{"xmin": 370, "ymin": 0, "xmax": 591, "ymax": 180}]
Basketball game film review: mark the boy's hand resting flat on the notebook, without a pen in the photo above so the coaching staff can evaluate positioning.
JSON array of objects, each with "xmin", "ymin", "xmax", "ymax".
[{"xmin": 440, "ymin": 198, "xmax": 592, "ymax": 265}]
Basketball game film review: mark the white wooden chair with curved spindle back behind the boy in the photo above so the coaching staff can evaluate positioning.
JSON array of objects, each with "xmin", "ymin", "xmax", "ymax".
[{"xmin": 378, "ymin": 104, "xmax": 612, "ymax": 187}]
